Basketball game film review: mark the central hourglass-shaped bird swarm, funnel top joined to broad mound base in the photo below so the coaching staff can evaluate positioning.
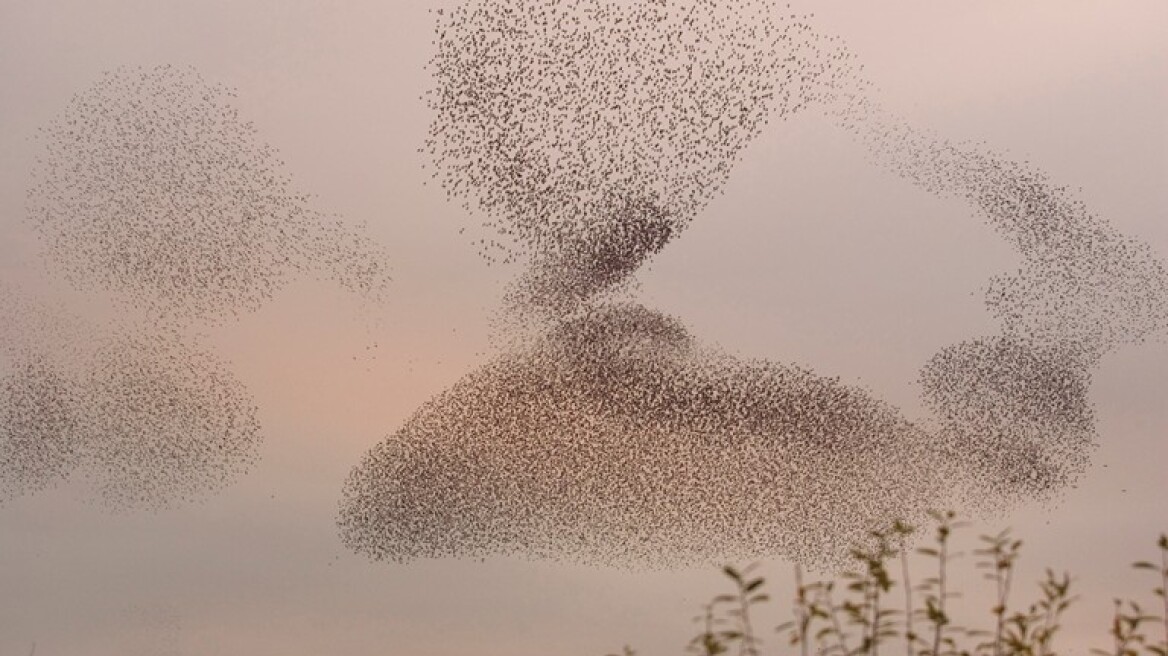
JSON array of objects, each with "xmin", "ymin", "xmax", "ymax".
[{"xmin": 340, "ymin": 0, "xmax": 920, "ymax": 564}]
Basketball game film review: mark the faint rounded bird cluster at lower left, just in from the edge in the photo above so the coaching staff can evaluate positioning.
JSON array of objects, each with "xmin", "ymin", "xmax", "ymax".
[{"xmin": 82, "ymin": 335, "xmax": 260, "ymax": 508}]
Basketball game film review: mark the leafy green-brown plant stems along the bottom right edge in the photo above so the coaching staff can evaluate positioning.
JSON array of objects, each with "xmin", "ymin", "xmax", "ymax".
[{"xmin": 625, "ymin": 511, "xmax": 1168, "ymax": 656}]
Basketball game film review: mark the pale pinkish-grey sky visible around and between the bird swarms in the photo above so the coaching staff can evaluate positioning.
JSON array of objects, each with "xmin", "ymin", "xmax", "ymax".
[{"xmin": 0, "ymin": 0, "xmax": 1168, "ymax": 656}]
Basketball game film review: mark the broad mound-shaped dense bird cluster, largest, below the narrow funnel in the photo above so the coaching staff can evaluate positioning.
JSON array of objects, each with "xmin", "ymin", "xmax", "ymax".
[{"xmin": 340, "ymin": 305, "xmax": 945, "ymax": 566}]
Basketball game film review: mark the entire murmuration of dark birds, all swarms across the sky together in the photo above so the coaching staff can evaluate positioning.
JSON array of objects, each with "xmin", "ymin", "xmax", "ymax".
[{"xmin": 0, "ymin": 0, "xmax": 1168, "ymax": 567}]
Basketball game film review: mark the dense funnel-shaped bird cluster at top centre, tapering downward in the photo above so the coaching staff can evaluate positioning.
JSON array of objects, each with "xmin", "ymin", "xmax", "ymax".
[{"xmin": 426, "ymin": 0, "xmax": 848, "ymax": 313}]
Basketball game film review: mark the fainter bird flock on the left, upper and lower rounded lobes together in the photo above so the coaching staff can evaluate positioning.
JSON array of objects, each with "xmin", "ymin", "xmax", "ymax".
[{"xmin": 0, "ymin": 65, "xmax": 389, "ymax": 508}]
